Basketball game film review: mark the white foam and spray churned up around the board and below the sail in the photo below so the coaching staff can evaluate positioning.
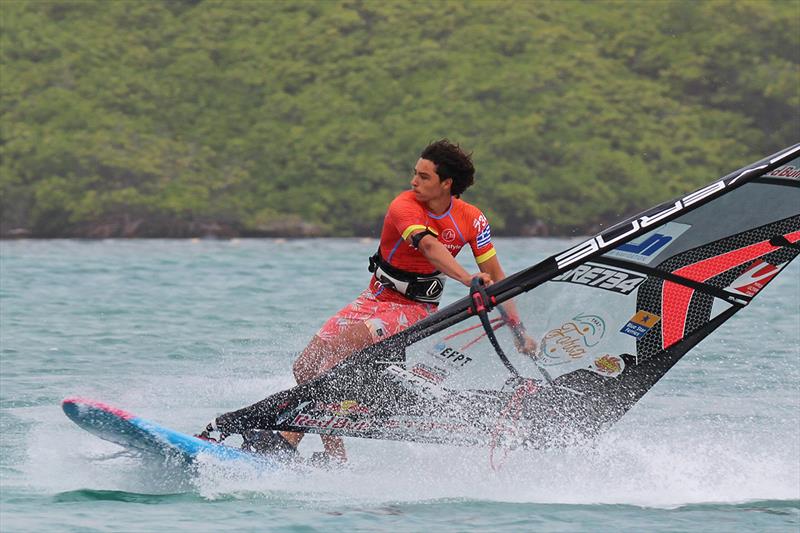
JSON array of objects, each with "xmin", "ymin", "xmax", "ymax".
[{"xmin": 20, "ymin": 358, "xmax": 800, "ymax": 508}]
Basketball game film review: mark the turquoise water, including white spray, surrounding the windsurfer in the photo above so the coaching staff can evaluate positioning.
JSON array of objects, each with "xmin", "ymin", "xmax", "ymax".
[{"xmin": 0, "ymin": 239, "xmax": 800, "ymax": 533}]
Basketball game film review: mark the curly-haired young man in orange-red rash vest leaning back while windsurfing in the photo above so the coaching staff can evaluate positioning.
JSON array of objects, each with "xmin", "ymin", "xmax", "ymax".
[{"xmin": 200, "ymin": 139, "xmax": 536, "ymax": 462}]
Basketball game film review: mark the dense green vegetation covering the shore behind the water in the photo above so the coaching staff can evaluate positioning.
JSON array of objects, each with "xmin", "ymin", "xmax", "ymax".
[{"xmin": 0, "ymin": 0, "xmax": 800, "ymax": 236}]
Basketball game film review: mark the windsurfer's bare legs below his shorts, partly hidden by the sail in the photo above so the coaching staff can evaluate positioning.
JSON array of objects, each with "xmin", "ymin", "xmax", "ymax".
[{"xmin": 281, "ymin": 322, "xmax": 374, "ymax": 460}]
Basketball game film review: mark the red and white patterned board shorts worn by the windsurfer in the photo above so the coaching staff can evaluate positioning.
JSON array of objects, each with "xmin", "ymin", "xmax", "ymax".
[{"xmin": 317, "ymin": 289, "xmax": 437, "ymax": 342}]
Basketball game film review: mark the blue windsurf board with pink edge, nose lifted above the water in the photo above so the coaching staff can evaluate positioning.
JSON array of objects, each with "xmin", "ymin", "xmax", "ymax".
[{"xmin": 61, "ymin": 398, "xmax": 279, "ymax": 469}]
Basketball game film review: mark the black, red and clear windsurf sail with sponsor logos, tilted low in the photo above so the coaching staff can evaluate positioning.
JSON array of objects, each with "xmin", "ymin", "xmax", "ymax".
[{"xmin": 217, "ymin": 144, "xmax": 800, "ymax": 447}]
